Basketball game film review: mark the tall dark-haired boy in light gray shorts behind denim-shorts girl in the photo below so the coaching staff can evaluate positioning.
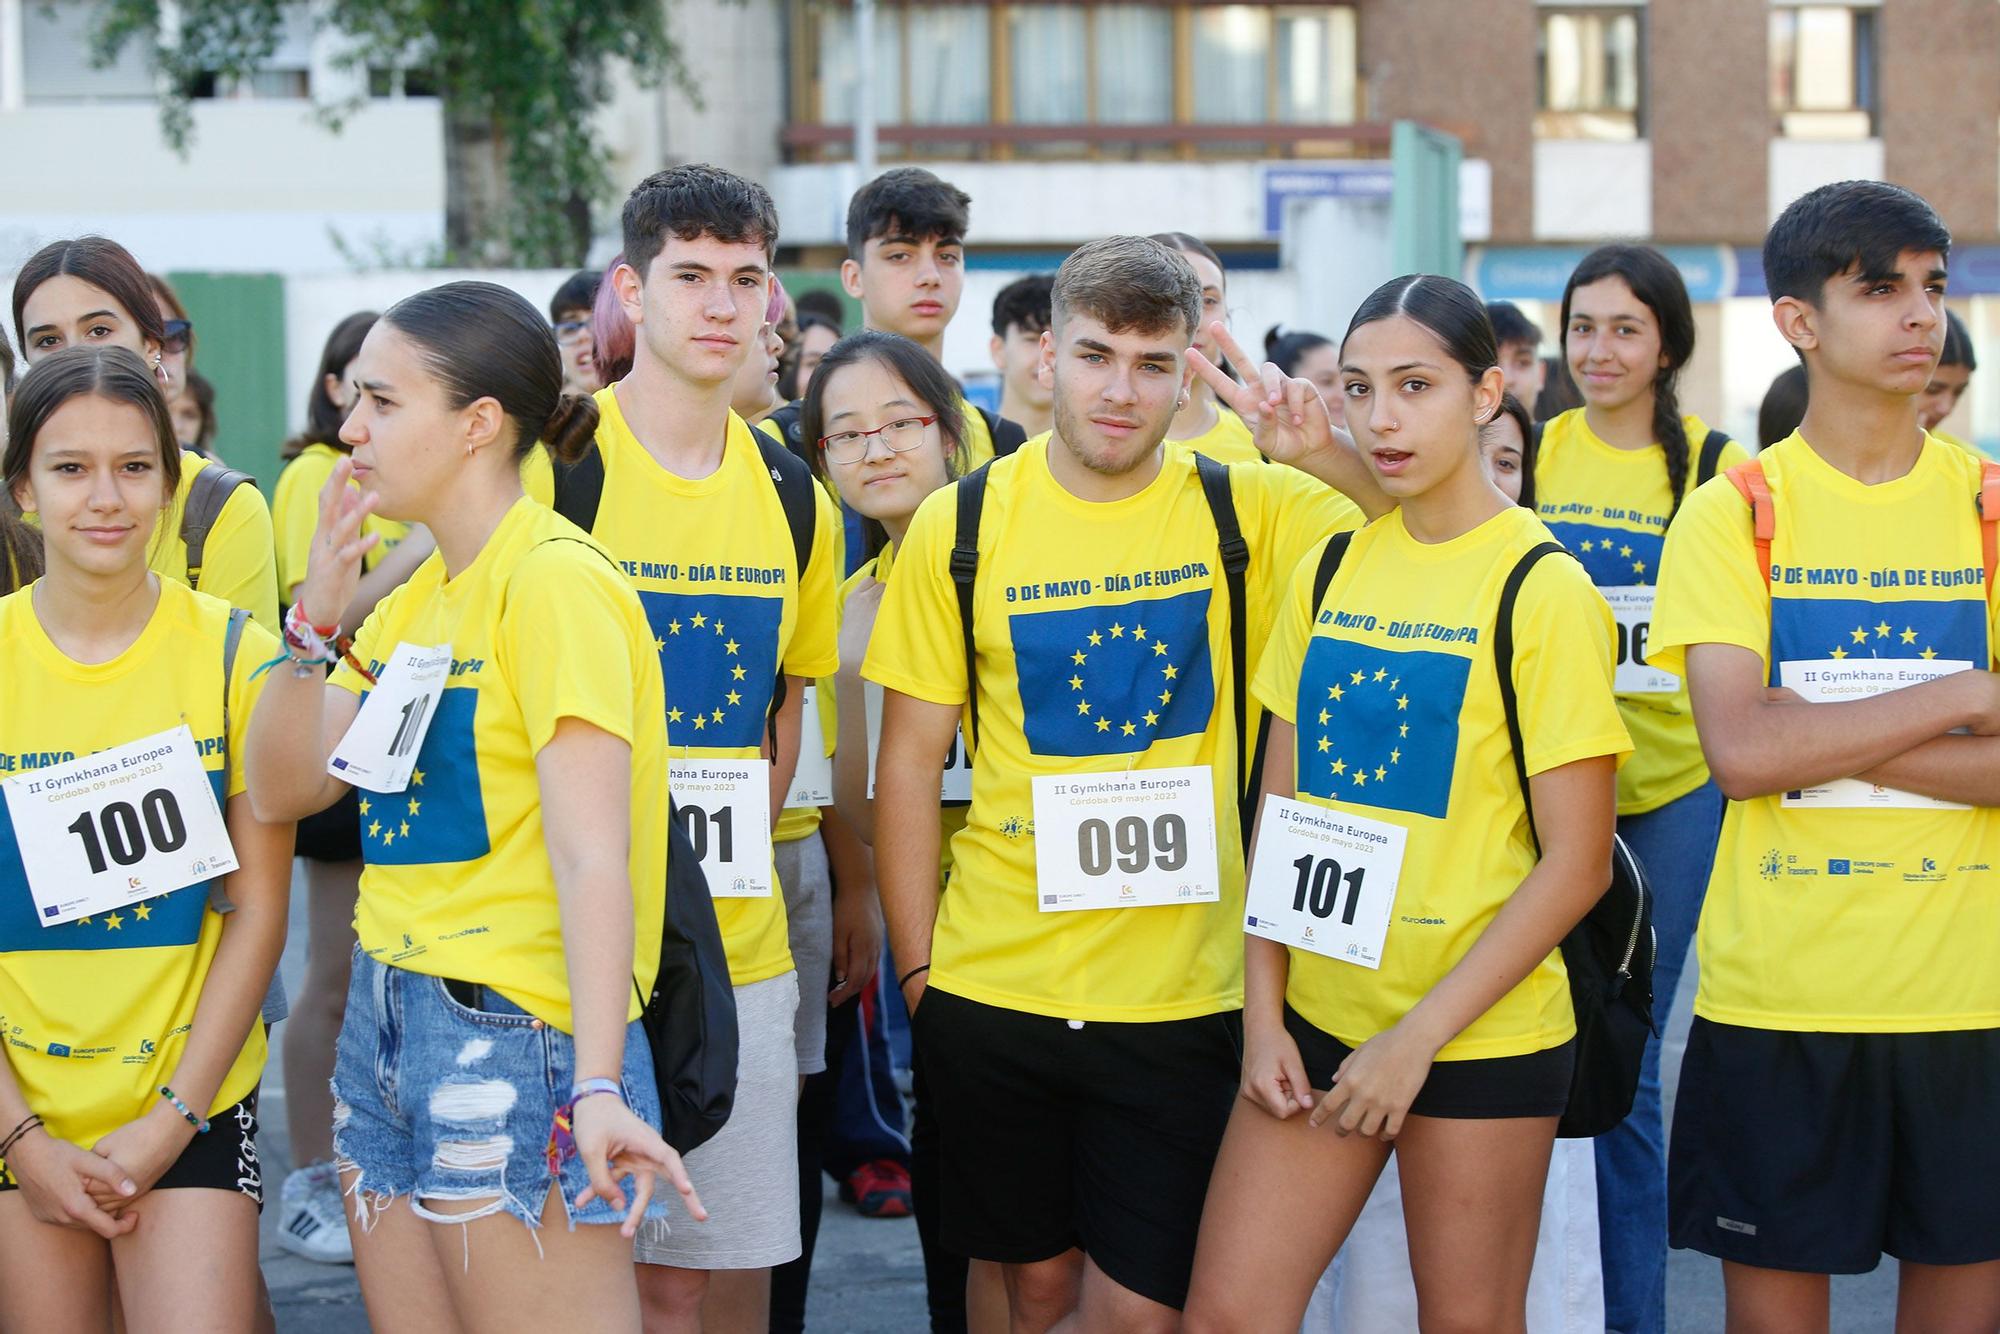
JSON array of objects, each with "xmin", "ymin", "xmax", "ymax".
[{"xmin": 532, "ymin": 164, "xmax": 838, "ymax": 1334}]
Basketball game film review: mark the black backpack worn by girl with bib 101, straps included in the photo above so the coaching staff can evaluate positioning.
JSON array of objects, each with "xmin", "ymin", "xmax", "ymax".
[{"xmin": 1312, "ymin": 532, "xmax": 1656, "ymax": 1140}]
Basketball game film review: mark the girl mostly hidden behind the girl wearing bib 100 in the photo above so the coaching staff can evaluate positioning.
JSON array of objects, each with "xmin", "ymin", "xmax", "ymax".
[{"xmin": 14, "ymin": 236, "xmax": 278, "ymax": 630}]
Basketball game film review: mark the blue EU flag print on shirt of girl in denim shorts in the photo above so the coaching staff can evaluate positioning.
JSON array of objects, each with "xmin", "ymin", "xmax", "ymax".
[{"xmin": 360, "ymin": 686, "xmax": 492, "ymax": 866}]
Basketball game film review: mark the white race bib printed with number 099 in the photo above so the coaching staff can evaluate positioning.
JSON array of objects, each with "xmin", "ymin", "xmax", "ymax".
[{"xmin": 1032, "ymin": 764, "xmax": 1222, "ymax": 912}]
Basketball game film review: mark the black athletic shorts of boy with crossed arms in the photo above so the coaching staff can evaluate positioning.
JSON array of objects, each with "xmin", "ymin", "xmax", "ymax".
[{"xmin": 1668, "ymin": 1018, "xmax": 2000, "ymax": 1274}]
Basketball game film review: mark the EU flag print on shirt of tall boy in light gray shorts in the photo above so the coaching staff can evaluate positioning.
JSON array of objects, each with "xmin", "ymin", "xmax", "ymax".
[{"xmin": 638, "ymin": 588, "xmax": 784, "ymax": 748}]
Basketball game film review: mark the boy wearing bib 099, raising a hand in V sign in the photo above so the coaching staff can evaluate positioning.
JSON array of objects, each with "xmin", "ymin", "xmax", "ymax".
[{"xmin": 862, "ymin": 236, "xmax": 1372, "ymax": 1332}]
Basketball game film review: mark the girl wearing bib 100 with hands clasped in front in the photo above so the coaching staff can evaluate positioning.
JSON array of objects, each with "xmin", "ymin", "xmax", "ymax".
[{"xmin": 0, "ymin": 346, "xmax": 292, "ymax": 1334}]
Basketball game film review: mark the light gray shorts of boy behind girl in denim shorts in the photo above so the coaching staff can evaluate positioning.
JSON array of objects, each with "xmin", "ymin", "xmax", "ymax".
[{"xmin": 632, "ymin": 972, "xmax": 804, "ymax": 1270}]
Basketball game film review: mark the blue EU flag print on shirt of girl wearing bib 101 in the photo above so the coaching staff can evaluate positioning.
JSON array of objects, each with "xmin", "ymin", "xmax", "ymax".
[{"xmin": 1298, "ymin": 636, "xmax": 1472, "ymax": 820}]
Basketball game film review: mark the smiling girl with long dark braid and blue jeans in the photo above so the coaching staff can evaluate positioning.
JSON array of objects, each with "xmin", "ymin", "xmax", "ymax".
[{"xmin": 1534, "ymin": 246, "xmax": 1748, "ymax": 1330}]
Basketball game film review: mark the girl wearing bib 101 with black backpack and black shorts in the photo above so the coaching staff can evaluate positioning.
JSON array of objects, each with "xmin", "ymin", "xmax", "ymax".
[{"xmin": 1186, "ymin": 276, "xmax": 1630, "ymax": 1330}]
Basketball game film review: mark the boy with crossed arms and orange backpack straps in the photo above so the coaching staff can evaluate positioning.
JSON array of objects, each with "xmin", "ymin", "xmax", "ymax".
[{"xmin": 1650, "ymin": 180, "xmax": 2000, "ymax": 1330}]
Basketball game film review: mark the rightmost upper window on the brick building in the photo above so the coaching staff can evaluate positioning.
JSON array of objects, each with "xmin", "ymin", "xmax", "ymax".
[{"xmin": 1770, "ymin": 4, "xmax": 1876, "ymax": 140}]
